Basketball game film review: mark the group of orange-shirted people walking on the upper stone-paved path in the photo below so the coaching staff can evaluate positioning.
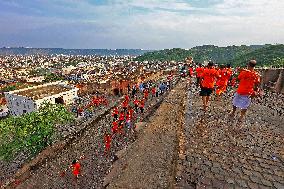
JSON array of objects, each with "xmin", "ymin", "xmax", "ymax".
[{"xmin": 189, "ymin": 60, "xmax": 262, "ymax": 124}]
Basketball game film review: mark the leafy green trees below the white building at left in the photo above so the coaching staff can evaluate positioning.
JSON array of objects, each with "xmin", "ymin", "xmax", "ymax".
[{"xmin": 0, "ymin": 104, "xmax": 74, "ymax": 161}]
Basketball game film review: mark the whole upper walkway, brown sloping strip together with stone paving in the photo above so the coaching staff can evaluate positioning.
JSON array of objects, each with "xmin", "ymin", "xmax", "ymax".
[{"xmin": 101, "ymin": 80, "xmax": 284, "ymax": 189}]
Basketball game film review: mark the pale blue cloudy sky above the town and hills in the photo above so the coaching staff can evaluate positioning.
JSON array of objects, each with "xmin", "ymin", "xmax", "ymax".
[{"xmin": 0, "ymin": 0, "xmax": 284, "ymax": 49}]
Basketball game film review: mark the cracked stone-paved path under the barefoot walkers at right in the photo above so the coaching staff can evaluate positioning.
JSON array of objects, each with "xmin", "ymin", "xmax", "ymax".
[{"xmin": 177, "ymin": 86, "xmax": 284, "ymax": 189}]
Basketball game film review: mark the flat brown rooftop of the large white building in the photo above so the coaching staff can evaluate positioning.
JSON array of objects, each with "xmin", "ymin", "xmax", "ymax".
[{"xmin": 14, "ymin": 84, "xmax": 70, "ymax": 100}]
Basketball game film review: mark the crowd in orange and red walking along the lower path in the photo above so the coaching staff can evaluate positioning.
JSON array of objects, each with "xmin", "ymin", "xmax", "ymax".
[{"xmin": 65, "ymin": 74, "xmax": 174, "ymax": 180}]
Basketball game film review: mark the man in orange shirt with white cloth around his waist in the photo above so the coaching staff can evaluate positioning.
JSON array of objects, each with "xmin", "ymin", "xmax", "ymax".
[{"xmin": 230, "ymin": 60, "xmax": 260, "ymax": 123}]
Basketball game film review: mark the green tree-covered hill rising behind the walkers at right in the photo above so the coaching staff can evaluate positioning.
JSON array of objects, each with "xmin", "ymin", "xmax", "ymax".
[{"xmin": 135, "ymin": 44, "xmax": 284, "ymax": 67}]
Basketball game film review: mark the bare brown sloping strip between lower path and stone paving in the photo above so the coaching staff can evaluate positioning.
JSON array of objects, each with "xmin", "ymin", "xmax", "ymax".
[{"xmin": 105, "ymin": 82, "xmax": 186, "ymax": 188}]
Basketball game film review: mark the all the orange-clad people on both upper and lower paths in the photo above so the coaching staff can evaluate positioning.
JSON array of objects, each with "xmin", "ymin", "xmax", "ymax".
[{"xmin": 64, "ymin": 60, "xmax": 260, "ymax": 183}]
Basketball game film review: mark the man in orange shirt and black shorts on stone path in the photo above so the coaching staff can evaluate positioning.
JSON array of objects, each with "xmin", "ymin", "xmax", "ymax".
[{"xmin": 200, "ymin": 62, "xmax": 219, "ymax": 112}]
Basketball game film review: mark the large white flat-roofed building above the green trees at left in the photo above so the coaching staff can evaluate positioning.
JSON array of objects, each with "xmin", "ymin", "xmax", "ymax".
[{"xmin": 5, "ymin": 82, "xmax": 79, "ymax": 116}]
